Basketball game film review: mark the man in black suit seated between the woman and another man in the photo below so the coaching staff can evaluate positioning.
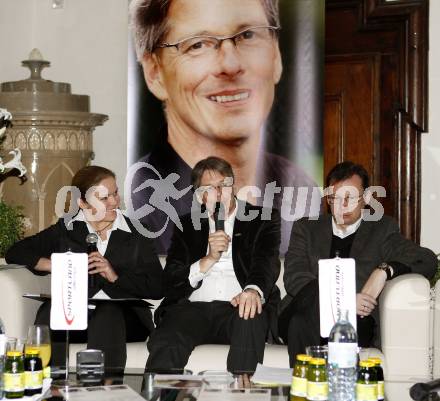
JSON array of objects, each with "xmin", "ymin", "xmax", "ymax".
[{"xmin": 146, "ymin": 157, "xmax": 280, "ymax": 373}]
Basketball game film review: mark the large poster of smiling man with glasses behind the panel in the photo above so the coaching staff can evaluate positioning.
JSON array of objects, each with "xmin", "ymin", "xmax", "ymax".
[{"xmin": 126, "ymin": 0, "xmax": 324, "ymax": 254}]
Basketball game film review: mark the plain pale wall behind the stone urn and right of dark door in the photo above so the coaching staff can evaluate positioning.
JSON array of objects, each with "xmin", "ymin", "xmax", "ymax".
[{"xmin": 0, "ymin": 0, "xmax": 440, "ymax": 252}]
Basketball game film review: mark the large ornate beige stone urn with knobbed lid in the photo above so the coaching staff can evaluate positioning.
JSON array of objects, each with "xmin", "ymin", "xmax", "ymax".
[{"xmin": 0, "ymin": 50, "xmax": 108, "ymax": 235}]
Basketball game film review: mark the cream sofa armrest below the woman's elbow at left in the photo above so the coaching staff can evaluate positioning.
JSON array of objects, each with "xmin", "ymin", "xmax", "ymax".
[{"xmin": 0, "ymin": 266, "xmax": 50, "ymax": 338}]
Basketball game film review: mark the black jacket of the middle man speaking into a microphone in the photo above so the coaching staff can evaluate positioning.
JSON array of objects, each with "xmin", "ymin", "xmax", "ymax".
[{"xmin": 157, "ymin": 201, "xmax": 281, "ymax": 338}]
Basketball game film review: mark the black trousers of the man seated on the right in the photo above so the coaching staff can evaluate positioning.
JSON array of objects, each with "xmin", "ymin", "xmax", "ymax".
[{"xmin": 278, "ymin": 281, "xmax": 376, "ymax": 367}]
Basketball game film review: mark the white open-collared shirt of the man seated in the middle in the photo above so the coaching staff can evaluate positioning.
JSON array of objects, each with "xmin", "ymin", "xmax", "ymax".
[{"xmin": 188, "ymin": 204, "xmax": 264, "ymax": 302}]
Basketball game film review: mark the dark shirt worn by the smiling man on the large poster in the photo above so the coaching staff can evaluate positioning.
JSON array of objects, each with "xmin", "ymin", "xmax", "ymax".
[{"xmin": 131, "ymin": 127, "xmax": 321, "ymax": 255}]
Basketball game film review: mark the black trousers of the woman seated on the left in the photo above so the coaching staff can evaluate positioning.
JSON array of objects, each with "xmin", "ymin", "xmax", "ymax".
[{"xmin": 35, "ymin": 301, "xmax": 149, "ymax": 370}]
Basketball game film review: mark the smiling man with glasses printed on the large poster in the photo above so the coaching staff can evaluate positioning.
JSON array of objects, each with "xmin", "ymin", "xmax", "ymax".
[{"xmin": 130, "ymin": 0, "xmax": 320, "ymax": 253}]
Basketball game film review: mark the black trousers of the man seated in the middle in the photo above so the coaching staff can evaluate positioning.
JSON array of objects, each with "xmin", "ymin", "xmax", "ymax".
[{"xmin": 146, "ymin": 301, "xmax": 269, "ymax": 373}]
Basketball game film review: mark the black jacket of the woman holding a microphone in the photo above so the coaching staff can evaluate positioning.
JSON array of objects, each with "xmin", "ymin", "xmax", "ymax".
[{"xmin": 6, "ymin": 218, "xmax": 163, "ymax": 299}]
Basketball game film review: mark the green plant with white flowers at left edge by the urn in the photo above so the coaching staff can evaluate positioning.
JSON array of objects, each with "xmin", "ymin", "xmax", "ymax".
[{"xmin": 0, "ymin": 108, "xmax": 26, "ymax": 265}]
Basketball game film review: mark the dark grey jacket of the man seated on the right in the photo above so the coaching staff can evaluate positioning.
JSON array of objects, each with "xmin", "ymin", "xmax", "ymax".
[{"xmin": 280, "ymin": 215, "xmax": 437, "ymax": 345}]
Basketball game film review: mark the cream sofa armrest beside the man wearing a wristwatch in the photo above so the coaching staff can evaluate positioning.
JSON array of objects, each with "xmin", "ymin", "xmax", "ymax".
[{"xmin": 379, "ymin": 274, "xmax": 432, "ymax": 380}]
